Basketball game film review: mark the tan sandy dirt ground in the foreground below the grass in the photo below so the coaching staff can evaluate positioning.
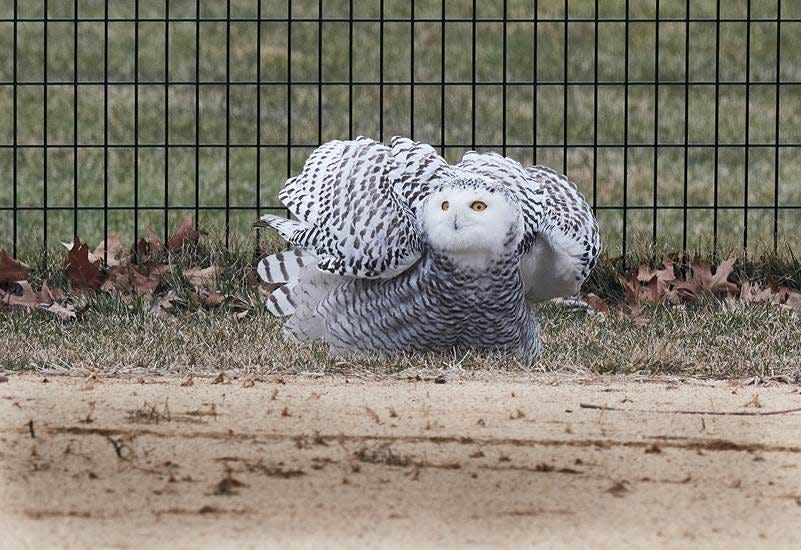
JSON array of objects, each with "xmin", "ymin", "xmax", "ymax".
[{"xmin": 0, "ymin": 375, "xmax": 801, "ymax": 548}]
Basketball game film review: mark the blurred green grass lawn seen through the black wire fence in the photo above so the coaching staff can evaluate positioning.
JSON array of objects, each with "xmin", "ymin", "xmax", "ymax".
[{"xmin": 0, "ymin": 0, "xmax": 801, "ymax": 259}]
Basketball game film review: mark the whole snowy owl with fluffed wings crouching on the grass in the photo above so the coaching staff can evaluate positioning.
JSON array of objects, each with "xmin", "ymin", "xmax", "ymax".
[{"xmin": 255, "ymin": 137, "xmax": 600, "ymax": 362}]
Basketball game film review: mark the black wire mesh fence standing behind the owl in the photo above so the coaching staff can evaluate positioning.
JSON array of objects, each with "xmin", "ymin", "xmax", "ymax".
[{"xmin": 0, "ymin": 0, "xmax": 801, "ymax": 262}]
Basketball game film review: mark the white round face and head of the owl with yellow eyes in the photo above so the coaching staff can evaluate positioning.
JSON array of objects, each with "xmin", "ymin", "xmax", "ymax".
[{"xmin": 422, "ymin": 178, "xmax": 523, "ymax": 269}]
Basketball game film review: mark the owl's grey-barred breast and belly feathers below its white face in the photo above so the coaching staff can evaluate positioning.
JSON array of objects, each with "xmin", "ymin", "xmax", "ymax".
[{"xmin": 320, "ymin": 251, "xmax": 540, "ymax": 360}]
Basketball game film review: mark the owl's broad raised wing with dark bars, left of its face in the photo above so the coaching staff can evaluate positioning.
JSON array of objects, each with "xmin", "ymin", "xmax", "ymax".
[{"xmin": 253, "ymin": 138, "xmax": 449, "ymax": 278}]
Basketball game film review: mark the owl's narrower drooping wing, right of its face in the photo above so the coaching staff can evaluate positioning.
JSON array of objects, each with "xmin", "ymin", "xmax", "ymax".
[{"xmin": 457, "ymin": 151, "xmax": 601, "ymax": 301}]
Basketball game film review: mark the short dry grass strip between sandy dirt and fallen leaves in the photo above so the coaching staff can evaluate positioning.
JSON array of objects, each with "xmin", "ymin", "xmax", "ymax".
[{"xmin": 0, "ymin": 303, "xmax": 801, "ymax": 379}]
